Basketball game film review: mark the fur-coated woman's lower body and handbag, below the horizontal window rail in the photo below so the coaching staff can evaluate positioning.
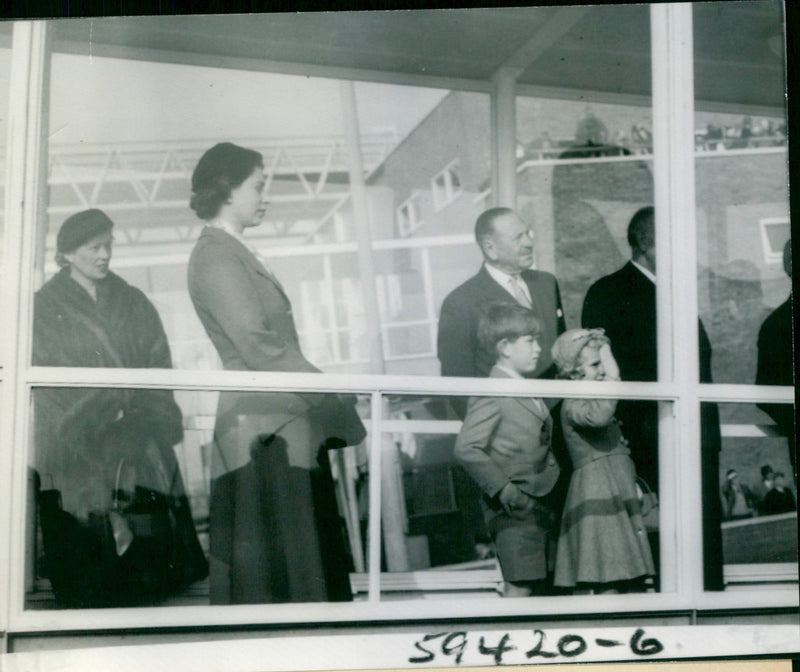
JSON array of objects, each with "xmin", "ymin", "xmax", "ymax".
[{"xmin": 33, "ymin": 388, "xmax": 208, "ymax": 607}]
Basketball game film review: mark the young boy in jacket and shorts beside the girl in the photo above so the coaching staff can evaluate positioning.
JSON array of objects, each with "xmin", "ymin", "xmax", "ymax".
[{"xmin": 455, "ymin": 303, "xmax": 560, "ymax": 597}]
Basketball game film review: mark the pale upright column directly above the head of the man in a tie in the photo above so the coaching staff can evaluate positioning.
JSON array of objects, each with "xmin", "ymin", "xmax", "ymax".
[{"xmin": 491, "ymin": 67, "xmax": 519, "ymax": 208}]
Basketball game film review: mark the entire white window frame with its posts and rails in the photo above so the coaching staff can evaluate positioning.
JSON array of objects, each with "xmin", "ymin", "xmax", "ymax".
[{"xmin": 0, "ymin": 4, "xmax": 797, "ymax": 632}]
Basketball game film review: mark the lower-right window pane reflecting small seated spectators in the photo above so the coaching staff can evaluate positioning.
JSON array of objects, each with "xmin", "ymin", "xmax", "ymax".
[{"xmin": 711, "ymin": 404, "xmax": 798, "ymax": 587}]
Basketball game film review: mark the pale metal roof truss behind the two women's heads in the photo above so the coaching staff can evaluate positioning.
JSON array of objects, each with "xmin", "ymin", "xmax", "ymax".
[{"xmin": 23, "ymin": 131, "xmax": 398, "ymax": 244}]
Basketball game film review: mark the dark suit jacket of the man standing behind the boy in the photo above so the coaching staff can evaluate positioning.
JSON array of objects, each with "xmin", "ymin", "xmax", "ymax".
[{"xmin": 438, "ymin": 266, "xmax": 566, "ymax": 417}]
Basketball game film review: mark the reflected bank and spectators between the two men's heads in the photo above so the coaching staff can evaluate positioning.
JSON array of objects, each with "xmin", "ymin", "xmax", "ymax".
[{"xmin": 517, "ymin": 97, "xmax": 653, "ymax": 334}]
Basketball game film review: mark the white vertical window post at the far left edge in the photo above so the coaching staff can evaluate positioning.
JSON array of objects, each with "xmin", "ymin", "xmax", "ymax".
[{"xmin": 0, "ymin": 21, "xmax": 50, "ymax": 630}]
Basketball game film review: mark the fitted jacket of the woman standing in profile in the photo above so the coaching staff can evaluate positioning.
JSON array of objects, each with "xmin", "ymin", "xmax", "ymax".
[{"xmin": 188, "ymin": 227, "xmax": 320, "ymax": 468}]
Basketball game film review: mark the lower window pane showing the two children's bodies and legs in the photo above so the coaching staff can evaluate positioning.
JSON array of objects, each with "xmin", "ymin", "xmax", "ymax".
[{"xmin": 381, "ymin": 397, "xmax": 659, "ymax": 599}]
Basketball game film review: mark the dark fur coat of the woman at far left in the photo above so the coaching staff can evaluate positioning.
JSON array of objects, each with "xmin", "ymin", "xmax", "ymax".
[{"xmin": 32, "ymin": 267, "xmax": 183, "ymax": 510}]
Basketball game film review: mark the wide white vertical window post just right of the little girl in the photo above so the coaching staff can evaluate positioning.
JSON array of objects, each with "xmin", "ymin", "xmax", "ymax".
[{"xmin": 650, "ymin": 3, "xmax": 696, "ymax": 594}]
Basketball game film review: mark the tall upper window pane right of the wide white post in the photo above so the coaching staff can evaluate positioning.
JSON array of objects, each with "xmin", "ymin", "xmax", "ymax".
[{"xmin": 694, "ymin": 2, "xmax": 793, "ymax": 385}]
